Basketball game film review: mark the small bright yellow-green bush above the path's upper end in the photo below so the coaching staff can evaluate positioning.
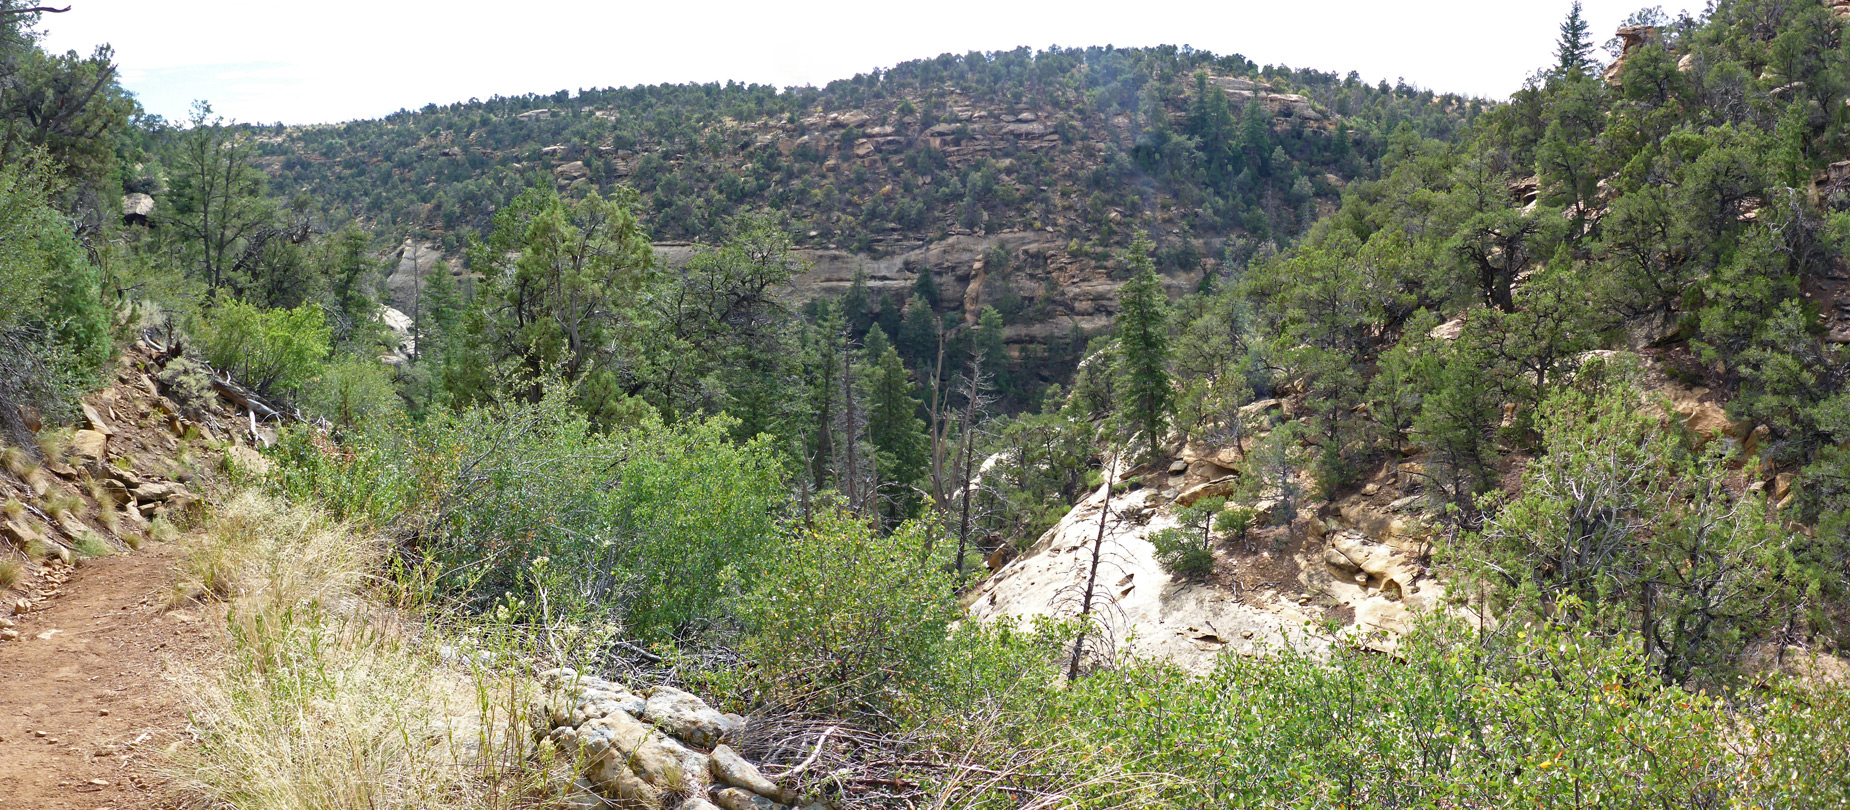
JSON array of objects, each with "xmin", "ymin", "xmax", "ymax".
[{"xmin": 194, "ymin": 298, "xmax": 331, "ymax": 396}]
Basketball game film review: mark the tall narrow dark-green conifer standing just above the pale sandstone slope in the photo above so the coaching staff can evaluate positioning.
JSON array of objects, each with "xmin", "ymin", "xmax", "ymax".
[{"xmin": 1114, "ymin": 235, "xmax": 1173, "ymax": 462}]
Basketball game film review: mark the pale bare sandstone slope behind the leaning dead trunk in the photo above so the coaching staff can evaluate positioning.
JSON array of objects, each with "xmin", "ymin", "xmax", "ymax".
[{"xmin": 966, "ymin": 432, "xmax": 1443, "ymax": 673}]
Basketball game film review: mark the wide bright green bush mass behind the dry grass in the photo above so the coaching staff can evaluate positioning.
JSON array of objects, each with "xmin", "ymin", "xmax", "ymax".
[{"xmin": 276, "ymin": 385, "xmax": 784, "ymax": 657}]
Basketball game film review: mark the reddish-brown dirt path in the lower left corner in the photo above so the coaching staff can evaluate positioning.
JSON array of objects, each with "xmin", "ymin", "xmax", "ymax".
[{"xmin": 0, "ymin": 544, "xmax": 218, "ymax": 810}]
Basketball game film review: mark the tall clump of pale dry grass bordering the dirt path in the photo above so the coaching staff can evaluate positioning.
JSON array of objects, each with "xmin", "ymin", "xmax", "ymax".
[{"xmin": 170, "ymin": 494, "xmax": 544, "ymax": 810}]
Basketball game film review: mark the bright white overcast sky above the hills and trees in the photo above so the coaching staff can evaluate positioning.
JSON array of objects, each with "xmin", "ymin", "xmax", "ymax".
[{"xmin": 41, "ymin": 0, "xmax": 1696, "ymax": 124}]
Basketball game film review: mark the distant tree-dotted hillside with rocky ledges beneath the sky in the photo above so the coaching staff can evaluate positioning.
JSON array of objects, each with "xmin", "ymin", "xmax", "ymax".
[{"xmin": 212, "ymin": 48, "xmax": 1486, "ymax": 373}]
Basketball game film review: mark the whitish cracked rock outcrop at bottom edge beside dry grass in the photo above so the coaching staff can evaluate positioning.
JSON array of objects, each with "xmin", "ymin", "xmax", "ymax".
[{"xmin": 535, "ymin": 669, "xmax": 827, "ymax": 810}]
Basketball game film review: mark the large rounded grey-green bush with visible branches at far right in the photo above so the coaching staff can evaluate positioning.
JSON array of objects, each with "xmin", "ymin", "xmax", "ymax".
[{"xmin": 1452, "ymin": 383, "xmax": 1805, "ymax": 682}]
